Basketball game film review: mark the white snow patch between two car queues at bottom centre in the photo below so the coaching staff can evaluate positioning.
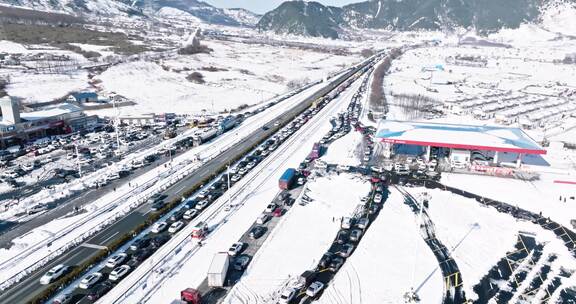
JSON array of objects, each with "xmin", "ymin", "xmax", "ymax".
[{"xmin": 224, "ymin": 174, "xmax": 370, "ymax": 304}]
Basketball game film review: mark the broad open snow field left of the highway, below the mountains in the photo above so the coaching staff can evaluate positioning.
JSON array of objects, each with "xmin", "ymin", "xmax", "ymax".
[{"xmin": 95, "ymin": 41, "xmax": 361, "ymax": 115}]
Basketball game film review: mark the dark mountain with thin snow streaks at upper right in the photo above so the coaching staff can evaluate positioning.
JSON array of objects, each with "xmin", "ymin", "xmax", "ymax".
[{"xmin": 257, "ymin": 0, "xmax": 564, "ymax": 38}]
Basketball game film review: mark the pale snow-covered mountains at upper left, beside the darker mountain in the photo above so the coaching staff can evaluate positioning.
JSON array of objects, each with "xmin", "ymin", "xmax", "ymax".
[{"xmin": 0, "ymin": 0, "xmax": 260, "ymax": 26}]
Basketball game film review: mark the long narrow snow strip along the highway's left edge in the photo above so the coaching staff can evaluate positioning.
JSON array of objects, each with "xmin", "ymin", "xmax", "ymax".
[{"xmin": 0, "ymin": 78, "xmax": 326, "ymax": 288}]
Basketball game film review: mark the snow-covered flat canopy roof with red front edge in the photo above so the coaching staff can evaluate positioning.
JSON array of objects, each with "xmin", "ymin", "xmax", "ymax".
[{"xmin": 376, "ymin": 120, "xmax": 546, "ymax": 154}]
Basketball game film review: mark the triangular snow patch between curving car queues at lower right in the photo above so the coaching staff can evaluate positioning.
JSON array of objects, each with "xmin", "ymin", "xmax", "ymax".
[{"xmin": 406, "ymin": 185, "xmax": 576, "ymax": 303}]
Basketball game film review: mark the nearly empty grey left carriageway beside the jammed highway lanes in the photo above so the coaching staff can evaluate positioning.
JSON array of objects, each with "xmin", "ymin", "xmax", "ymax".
[{"xmin": 0, "ymin": 56, "xmax": 378, "ymax": 303}]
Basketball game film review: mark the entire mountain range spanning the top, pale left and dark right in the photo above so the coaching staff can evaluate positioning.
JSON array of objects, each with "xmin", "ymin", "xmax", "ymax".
[{"xmin": 0, "ymin": 0, "xmax": 576, "ymax": 38}]
